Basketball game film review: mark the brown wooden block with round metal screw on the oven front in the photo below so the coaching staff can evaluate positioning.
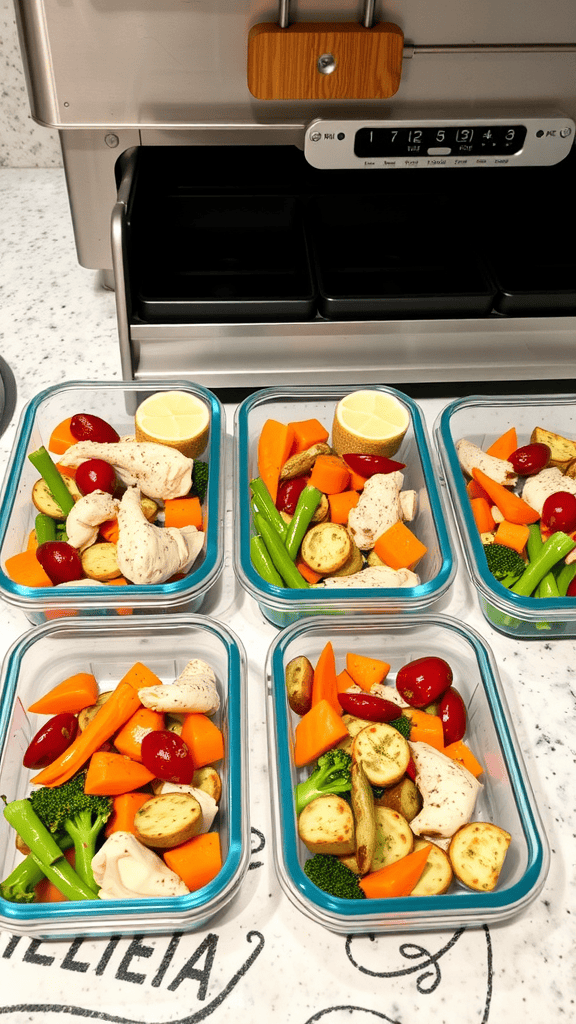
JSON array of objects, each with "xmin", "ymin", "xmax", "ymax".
[{"xmin": 248, "ymin": 22, "xmax": 404, "ymax": 99}]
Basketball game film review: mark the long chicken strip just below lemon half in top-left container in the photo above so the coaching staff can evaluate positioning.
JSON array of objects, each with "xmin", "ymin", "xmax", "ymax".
[{"xmin": 59, "ymin": 441, "xmax": 194, "ymax": 499}]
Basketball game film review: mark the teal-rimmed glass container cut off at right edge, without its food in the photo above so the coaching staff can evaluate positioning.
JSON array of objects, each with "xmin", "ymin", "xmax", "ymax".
[{"xmin": 434, "ymin": 394, "xmax": 576, "ymax": 640}]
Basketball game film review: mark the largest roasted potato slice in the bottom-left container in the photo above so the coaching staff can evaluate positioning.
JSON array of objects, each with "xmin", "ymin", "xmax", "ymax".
[{"xmin": 134, "ymin": 793, "xmax": 203, "ymax": 849}]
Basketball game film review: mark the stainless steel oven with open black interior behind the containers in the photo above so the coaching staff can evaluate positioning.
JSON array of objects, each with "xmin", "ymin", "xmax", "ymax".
[{"xmin": 15, "ymin": 0, "xmax": 576, "ymax": 389}]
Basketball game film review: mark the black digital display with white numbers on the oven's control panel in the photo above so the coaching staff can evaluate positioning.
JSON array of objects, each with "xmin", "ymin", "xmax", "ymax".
[{"xmin": 354, "ymin": 125, "xmax": 527, "ymax": 157}]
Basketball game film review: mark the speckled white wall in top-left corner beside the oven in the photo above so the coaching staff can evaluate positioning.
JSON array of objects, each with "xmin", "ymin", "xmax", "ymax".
[{"xmin": 0, "ymin": 0, "xmax": 61, "ymax": 167}]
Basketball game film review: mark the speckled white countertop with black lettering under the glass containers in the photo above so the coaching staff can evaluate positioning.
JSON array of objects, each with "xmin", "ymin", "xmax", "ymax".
[{"xmin": 0, "ymin": 169, "xmax": 576, "ymax": 1024}]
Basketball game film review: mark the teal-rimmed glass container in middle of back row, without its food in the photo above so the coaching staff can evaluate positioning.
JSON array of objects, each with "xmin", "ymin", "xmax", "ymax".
[{"xmin": 234, "ymin": 384, "xmax": 455, "ymax": 626}]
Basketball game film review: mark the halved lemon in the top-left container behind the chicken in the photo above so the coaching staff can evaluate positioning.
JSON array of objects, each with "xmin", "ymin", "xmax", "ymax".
[{"xmin": 134, "ymin": 391, "xmax": 210, "ymax": 459}]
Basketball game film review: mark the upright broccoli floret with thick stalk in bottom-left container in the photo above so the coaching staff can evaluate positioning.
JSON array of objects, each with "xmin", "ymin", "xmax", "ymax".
[{"xmin": 29, "ymin": 771, "xmax": 113, "ymax": 890}]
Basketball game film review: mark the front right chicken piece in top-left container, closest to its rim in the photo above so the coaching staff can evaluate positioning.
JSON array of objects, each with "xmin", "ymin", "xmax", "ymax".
[{"xmin": 116, "ymin": 487, "xmax": 204, "ymax": 584}]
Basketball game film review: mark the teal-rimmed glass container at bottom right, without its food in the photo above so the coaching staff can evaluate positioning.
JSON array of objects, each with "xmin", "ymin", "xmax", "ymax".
[{"xmin": 266, "ymin": 614, "xmax": 549, "ymax": 934}]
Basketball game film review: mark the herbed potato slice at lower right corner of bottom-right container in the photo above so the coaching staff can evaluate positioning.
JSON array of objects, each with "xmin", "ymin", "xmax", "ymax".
[{"xmin": 448, "ymin": 821, "xmax": 511, "ymax": 892}]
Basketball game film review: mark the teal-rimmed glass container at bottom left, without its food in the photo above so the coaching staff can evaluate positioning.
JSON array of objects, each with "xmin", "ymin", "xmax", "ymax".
[{"xmin": 0, "ymin": 615, "xmax": 250, "ymax": 939}]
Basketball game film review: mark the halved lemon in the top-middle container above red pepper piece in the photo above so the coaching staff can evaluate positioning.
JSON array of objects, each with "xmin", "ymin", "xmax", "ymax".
[{"xmin": 332, "ymin": 389, "xmax": 410, "ymax": 458}]
